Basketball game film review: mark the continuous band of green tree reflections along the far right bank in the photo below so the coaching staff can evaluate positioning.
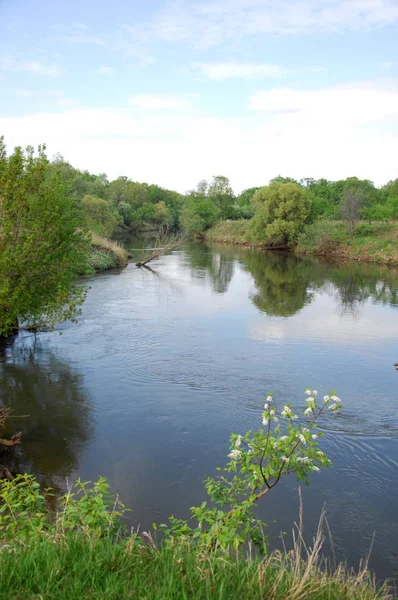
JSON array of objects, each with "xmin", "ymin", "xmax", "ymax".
[{"xmin": 199, "ymin": 245, "xmax": 398, "ymax": 317}]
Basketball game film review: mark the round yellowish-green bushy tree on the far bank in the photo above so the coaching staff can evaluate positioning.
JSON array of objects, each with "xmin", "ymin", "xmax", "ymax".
[{"xmin": 248, "ymin": 182, "xmax": 309, "ymax": 246}]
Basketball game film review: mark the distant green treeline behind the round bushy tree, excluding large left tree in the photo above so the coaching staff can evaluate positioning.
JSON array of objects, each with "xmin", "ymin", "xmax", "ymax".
[{"xmin": 51, "ymin": 155, "xmax": 398, "ymax": 236}]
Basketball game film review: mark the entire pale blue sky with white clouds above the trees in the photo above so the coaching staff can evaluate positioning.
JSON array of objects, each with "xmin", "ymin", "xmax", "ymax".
[{"xmin": 0, "ymin": 0, "xmax": 398, "ymax": 193}]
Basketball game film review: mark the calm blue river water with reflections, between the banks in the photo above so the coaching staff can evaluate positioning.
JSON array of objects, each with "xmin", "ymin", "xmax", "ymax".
[{"xmin": 0, "ymin": 240, "xmax": 398, "ymax": 578}]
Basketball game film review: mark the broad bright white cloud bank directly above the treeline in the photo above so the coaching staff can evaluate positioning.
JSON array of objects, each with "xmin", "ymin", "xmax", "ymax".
[{"xmin": 0, "ymin": 81, "xmax": 398, "ymax": 192}]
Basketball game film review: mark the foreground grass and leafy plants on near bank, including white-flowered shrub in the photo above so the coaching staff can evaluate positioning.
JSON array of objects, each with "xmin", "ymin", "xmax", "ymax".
[{"xmin": 0, "ymin": 389, "xmax": 391, "ymax": 600}]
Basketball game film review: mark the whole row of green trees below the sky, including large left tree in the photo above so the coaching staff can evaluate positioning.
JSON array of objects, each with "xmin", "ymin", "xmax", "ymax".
[{"xmin": 0, "ymin": 137, "xmax": 398, "ymax": 336}]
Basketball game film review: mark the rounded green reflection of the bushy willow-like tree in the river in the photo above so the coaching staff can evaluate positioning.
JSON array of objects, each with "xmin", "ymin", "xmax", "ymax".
[{"xmin": 242, "ymin": 252, "xmax": 312, "ymax": 317}]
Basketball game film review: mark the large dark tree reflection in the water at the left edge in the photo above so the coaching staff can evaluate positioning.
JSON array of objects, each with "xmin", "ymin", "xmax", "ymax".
[{"xmin": 0, "ymin": 337, "xmax": 92, "ymax": 485}]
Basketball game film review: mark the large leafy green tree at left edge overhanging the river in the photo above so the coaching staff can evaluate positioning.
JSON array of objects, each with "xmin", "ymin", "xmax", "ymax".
[{"xmin": 0, "ymin": 138, "xmax": 88, "ymax": 335}]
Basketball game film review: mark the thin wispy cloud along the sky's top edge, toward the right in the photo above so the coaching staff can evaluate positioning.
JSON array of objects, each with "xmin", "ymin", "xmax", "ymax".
[{"xmin": 124, "ymin": 0, "xmax": 398, "ymax": 47}]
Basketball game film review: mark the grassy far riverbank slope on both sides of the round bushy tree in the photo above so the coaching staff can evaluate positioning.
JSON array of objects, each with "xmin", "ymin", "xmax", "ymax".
[{"xmin": 205, "ymin": 219, "xmax": 398, "ymax": 265}]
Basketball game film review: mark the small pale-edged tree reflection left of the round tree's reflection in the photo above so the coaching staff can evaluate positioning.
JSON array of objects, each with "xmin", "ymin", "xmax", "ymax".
[{"xmin": 187, "ymin": 244, "xmax": 234, "ymax": 294}]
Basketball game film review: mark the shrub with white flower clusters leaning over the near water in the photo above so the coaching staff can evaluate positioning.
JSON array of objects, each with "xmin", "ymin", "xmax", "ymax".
[{"xmin": 164, "ymin": 388, "xmax": 342, "ymax": 551}]
